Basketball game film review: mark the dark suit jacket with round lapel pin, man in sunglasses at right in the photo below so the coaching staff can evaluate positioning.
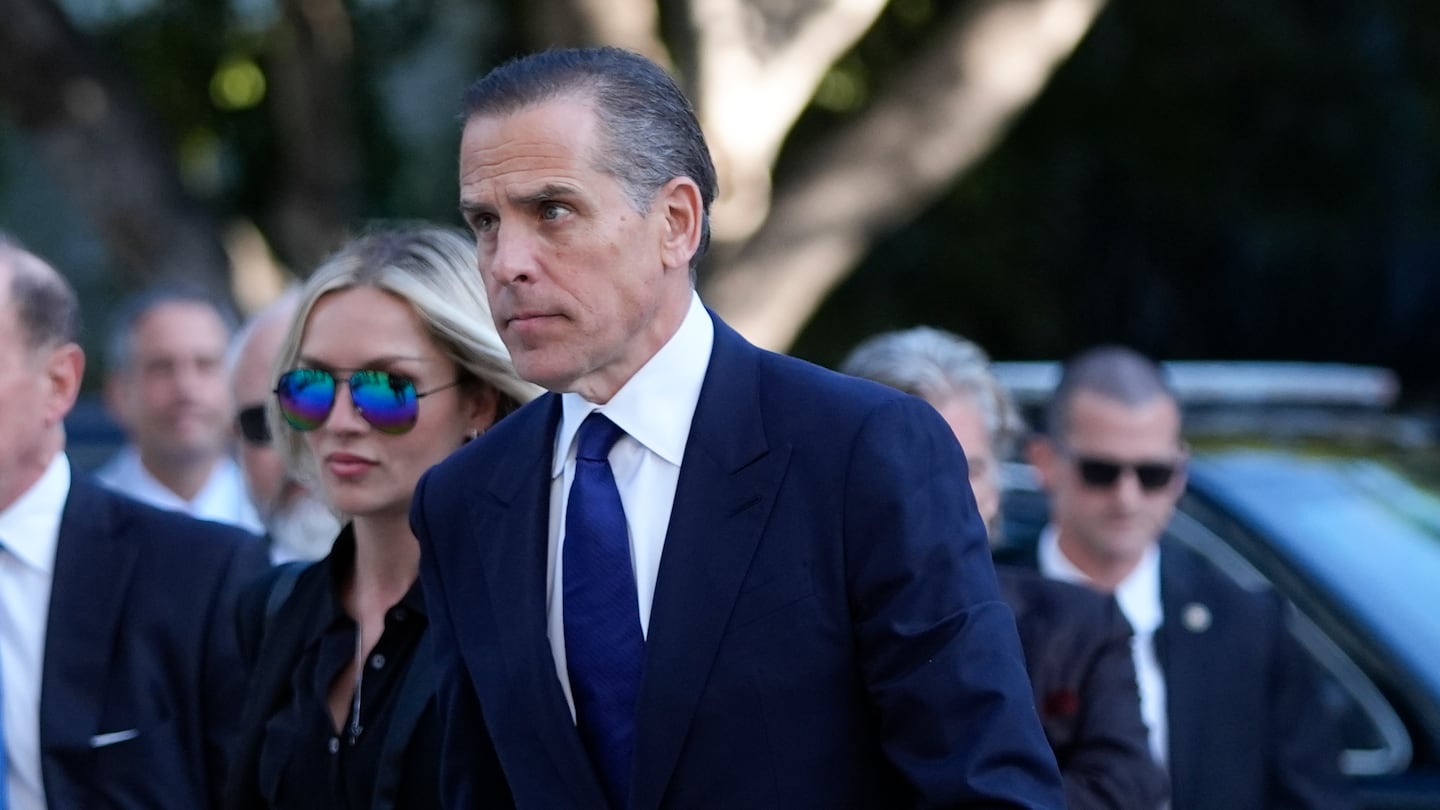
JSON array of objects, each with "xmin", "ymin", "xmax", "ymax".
[{"xmin": 1002, "ymin": 540, "xmax": 1352, "ymax": 810}]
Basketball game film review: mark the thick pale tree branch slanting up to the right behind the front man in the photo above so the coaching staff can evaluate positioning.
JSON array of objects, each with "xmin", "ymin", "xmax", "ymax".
[{"xmin": 704, "ymin": 0, "xmax": 1104, "ymax": 350}]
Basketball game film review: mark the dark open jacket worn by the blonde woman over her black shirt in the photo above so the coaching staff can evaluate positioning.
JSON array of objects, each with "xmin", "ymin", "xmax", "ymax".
[{"xmin": 225, "ymin": 539, "xmax": 435, "ymax": 810}]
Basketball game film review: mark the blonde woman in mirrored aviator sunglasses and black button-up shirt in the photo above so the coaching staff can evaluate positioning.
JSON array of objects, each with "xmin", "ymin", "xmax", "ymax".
[{"xmin": 226, "ymin": 226, "xmax": 539, "ymax": 810}]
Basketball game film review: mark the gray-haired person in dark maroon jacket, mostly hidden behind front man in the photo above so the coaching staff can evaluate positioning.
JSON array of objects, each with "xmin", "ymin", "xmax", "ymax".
[{"xmin": 841, "ymin": 327, "xmax": 1168, "ymax": 810}]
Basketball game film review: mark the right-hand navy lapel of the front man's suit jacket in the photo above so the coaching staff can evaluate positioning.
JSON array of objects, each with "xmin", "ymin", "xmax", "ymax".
[{"xmin": 631, "ymin": 314, "xmax": 789, "ymax": 809}]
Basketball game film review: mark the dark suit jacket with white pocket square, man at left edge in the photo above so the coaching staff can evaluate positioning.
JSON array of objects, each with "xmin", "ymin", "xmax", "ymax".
[{"xmin": 40, "ymin": 470, "xmax": 269, "ymax": 810}]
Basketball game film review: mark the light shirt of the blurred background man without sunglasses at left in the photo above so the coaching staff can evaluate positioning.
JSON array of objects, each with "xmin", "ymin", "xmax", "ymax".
[{"xmin": 95, "ymin": 444, "xmax": 265, "ymax": 535}]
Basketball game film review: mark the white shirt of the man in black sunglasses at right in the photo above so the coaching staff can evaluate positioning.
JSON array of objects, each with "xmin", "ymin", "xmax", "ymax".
[{"xmin": 1037, "ymin": 525, "xmax": 1169, "ymax": 765}]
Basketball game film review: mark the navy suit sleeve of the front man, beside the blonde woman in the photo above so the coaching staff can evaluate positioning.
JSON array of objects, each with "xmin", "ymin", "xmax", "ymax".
[{"xmin": 410, "ymin": 474, "xmax": 514, "ymax": 810}]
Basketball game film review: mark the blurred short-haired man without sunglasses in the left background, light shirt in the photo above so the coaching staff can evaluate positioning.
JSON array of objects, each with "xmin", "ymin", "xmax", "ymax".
[{"xmin": 98, "ymin": 281, "xmax": 264, "ymax": 533}]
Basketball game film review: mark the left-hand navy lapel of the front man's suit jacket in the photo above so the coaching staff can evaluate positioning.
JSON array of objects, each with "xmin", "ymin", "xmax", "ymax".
[{"xmin": 452, "ymin": 395, "xmax": 603, "ymax": 807}]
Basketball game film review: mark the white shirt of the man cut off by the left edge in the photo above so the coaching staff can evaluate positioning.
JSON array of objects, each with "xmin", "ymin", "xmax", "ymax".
[{"xmin": 0, "ymin": 453, "xmax": 71, "ymax": 810}]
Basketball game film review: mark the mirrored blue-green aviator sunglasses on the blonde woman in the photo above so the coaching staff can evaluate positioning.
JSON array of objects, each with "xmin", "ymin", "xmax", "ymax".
[{"xmin": 275, "ymin": 369, "xmax": 462, "ymax": 435}]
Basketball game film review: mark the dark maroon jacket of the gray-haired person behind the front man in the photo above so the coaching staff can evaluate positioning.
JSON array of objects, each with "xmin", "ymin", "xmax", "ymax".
[{"xmin": 995, "ymin": 565, "xmax": 1169, "ymax": 810}]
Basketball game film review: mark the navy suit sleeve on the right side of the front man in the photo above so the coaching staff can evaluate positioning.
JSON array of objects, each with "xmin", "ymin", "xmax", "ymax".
[{"xmin": 844, "ymin": 398, "xmax": 1064, "ymax": 807}]
